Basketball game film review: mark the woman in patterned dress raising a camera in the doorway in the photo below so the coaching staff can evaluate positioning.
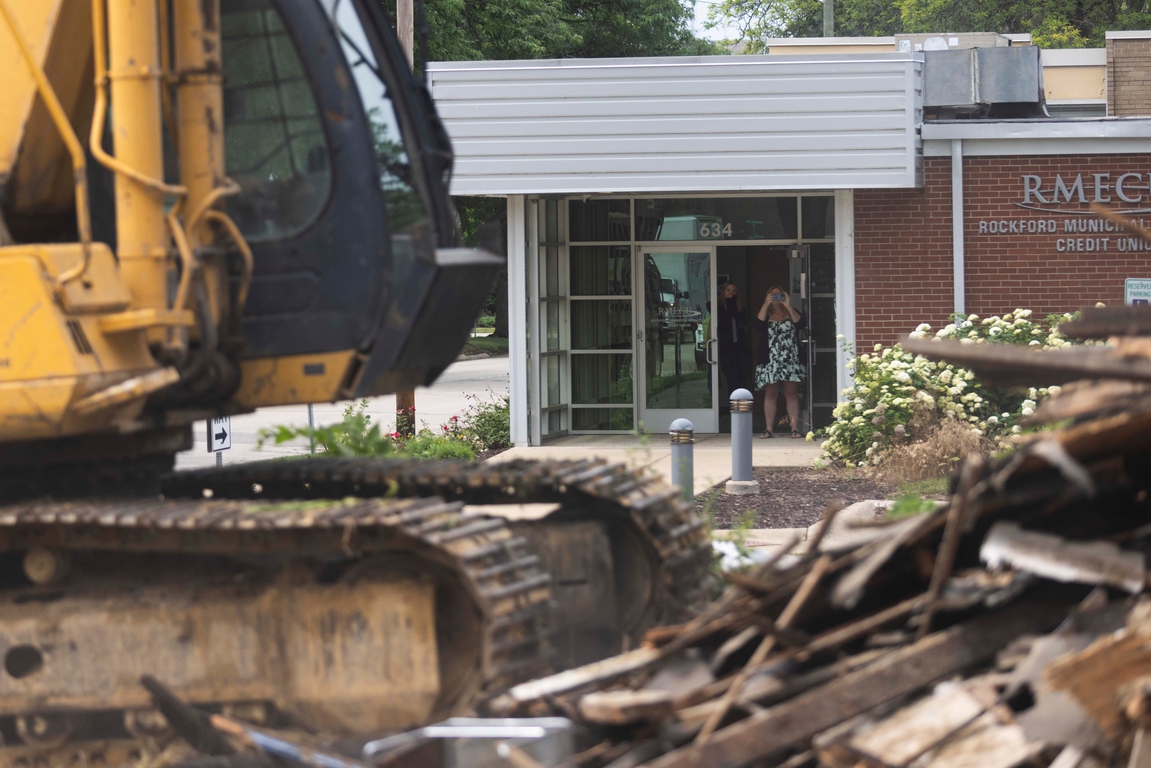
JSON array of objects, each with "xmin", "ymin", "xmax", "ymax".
[{"xmin": 755, "ymin": 286, "xmax": 807, "ymax": 439}]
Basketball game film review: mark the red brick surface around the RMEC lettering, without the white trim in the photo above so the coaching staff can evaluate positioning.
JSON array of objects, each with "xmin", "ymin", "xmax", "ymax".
[{"xmin": 855, "ymin": 155, "xmax": 1151, "ymax": 349}]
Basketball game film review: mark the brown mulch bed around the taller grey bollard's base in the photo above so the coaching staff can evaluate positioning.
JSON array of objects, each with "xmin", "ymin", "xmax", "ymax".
[{"xmin": 695, "ymin": 466, "xmax": 897, "ymax": 529}]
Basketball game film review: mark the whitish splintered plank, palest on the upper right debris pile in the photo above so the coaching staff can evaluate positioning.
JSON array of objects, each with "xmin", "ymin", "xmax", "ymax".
[{"xmin": 980, "ymin": 522, "xmax": 1148, "ymax": 594}]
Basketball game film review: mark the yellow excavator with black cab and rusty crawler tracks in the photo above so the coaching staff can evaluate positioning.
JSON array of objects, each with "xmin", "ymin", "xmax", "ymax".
[{"xmin": 0, "ymin": 0, "xmax": 710, "ymax": 766}]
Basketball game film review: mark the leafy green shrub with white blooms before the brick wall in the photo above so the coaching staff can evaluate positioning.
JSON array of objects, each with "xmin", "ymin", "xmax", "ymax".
[{"xmin": 823, "ymin": 310, "xmax": 1076, "ymax": 466}]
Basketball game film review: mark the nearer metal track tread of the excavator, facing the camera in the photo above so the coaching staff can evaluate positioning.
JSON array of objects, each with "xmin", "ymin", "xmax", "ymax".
[{"xmin": 0, "ymin": 496, "xmax": 551, "ymax": 732}]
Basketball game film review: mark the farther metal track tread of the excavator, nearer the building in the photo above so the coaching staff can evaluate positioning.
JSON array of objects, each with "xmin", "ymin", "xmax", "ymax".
[{"xmin": 161, "ymin": 457, "xmax": 714, "ymax": 621}]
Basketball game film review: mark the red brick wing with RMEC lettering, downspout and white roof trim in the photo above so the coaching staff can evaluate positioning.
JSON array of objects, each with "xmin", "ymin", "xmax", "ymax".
[{"xmin": 854, "ymin": 142, "xmax": 1151, "ymax": 347}]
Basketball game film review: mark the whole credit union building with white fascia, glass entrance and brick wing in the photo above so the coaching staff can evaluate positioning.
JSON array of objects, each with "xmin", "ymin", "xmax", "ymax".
[{"xmin": 429, "ymin": 32, "xmax": 1151, "ymax": 444}]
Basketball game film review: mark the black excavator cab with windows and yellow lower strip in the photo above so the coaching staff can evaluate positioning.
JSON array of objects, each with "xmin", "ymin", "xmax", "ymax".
[{"xmin": 220, "ymin": 0, "xmax": 498, "ymax": 406}]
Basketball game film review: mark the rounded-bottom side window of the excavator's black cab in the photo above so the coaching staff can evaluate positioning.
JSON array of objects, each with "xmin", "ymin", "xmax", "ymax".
[{"xmin": 220, "ymin": 0, "xmax": 331, "ymax": 242}]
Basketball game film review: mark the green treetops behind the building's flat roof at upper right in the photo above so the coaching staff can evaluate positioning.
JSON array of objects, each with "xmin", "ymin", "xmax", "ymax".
[{"xmin": 708, "ymin": 0, "xmax": 1151, "ymax": 53}]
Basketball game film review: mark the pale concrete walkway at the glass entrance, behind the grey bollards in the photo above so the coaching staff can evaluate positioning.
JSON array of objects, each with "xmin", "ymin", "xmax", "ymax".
[{"xmin": 490, "ymin": 434, "xmax": 822, "ymax": 494}]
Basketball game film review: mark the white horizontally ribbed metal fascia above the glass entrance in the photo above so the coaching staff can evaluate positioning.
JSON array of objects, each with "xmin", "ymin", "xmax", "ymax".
[{"xmin": 429, "ymin": 53, "xmax": 923, "ymax": 195}]
